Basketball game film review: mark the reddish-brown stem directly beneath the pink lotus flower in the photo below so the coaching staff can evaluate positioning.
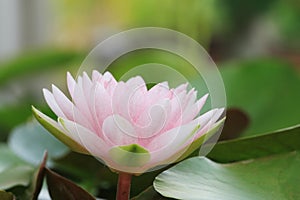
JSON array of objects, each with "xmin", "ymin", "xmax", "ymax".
[{"xmin": 116, "ymin": 172, "xmax": 132, "ymax": 200}]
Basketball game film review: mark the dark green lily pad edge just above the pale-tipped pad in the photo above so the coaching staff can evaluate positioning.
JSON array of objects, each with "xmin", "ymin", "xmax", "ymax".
[{"xmin": 207, "ymin": 124, "xmax": 300, "ymax": 163}]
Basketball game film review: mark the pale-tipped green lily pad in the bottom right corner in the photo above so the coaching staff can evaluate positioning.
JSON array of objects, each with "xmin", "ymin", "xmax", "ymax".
[{"xmin": 154, "ymin": 152, "xmax": 300, "ymax": 200}]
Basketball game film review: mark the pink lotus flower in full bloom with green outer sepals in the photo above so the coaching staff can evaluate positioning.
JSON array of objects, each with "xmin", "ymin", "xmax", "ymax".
[{"xmin": 33, "ymin": 71, "xmax": 224, "ymax": 174}]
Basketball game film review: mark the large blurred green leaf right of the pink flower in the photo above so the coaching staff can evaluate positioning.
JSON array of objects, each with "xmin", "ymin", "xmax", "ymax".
[{"xmin": 221, "ymin": 59, "xmax": 300, "ymax": 135}]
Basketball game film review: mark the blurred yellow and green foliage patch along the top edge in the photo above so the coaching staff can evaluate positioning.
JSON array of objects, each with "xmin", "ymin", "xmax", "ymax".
[{"xmin": 54, "ymin": 0, "xmax": 227, "ymax": 47}]
